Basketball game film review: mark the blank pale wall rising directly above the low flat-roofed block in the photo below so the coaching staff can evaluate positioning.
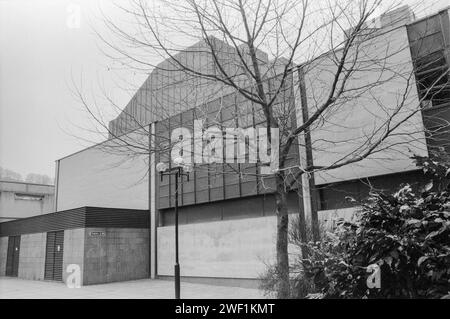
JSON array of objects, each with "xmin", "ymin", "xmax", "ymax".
[{"xmin": 57, "ymin": 130, "xmax": 148, "ymax": 211}]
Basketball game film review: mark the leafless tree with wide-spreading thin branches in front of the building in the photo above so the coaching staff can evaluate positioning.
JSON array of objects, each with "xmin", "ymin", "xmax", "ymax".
[{"xmin": 76, "ymin": 0, "xmax": 448, "ymax": 298}]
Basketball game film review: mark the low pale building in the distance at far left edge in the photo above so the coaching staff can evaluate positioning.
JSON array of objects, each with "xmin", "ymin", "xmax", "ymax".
[{"xmin": 0, "ymin": 180, "xmax": 55, "ymax": 222}]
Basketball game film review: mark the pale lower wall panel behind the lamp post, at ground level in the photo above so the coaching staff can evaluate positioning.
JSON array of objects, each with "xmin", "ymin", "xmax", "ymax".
[{"xmin": 158, "ymin": 216, "xmax": 276, "ymax": 278}]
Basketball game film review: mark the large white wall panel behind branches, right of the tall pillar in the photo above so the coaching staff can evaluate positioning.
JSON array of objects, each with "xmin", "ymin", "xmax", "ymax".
[{"xmin": 297, "ymin": 27, "xmax": 427, "ymax": 185}]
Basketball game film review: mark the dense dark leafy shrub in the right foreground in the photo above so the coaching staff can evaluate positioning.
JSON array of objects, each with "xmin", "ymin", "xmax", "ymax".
[{"xmin": 262, "ymin": 154, "xmax": 450, "ymax": 298}]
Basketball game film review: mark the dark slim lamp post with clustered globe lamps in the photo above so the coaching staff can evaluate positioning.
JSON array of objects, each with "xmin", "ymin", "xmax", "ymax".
[{"xmin": 156, "ymin": 157, "xmax": 190, "ymax": 299}]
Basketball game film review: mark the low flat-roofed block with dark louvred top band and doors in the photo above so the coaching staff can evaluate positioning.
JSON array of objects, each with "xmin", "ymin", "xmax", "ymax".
[{"xmin": 0, "ymin": 207, "xmax": 149, "ymax": 285}]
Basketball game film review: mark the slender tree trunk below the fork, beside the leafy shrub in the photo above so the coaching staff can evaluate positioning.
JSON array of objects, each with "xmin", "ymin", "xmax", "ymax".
[{"xmin": 275, "ymin": 174, "xmax": 290, "ymax": 299}]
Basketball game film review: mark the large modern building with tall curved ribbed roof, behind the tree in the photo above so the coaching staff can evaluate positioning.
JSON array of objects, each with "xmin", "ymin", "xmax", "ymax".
[{"xmin": 0, "ymin": 8, "xmax": 450, "ymax": 286}]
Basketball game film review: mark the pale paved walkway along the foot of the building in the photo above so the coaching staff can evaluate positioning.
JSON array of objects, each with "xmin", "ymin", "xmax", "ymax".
[{"xmin": 0, "ymin": 277, "xmax": 263, "ymax": 299}]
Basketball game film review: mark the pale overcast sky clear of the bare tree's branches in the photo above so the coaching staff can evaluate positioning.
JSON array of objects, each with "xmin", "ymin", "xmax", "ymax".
[{"xmin": 0, "ymin": 0, "xmax": 448, "ymax": 177}]
